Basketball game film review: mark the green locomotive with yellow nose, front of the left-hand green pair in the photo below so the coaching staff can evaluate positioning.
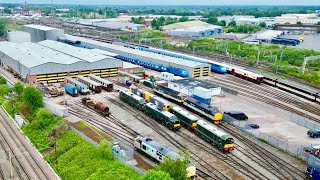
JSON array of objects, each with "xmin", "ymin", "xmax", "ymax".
[{"xmin": 144, "ymin": 103, "xmax": 181, "ymax": 130}]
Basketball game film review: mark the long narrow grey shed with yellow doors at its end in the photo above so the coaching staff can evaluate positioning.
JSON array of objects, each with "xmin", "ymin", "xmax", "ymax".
[{"xmin": 59, "ymin": 35, "xmax": 210, "ymax": 78}]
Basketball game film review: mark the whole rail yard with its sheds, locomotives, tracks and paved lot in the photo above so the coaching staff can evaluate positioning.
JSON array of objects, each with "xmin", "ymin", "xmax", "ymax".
[{"xmin": 0, "ymin": 25, "xmax": 320, "ymax": 179}]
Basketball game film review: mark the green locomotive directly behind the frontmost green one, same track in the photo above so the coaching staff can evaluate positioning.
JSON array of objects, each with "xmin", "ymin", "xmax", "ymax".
[{"xmin": 170, "ymin": 107, "xmax": 198, "ymax": 129}]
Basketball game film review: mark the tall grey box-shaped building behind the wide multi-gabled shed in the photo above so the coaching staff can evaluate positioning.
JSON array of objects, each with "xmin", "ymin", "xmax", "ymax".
[{"xmin": 23, "ymin": 24, "xmax": 64, "ymax": 42}]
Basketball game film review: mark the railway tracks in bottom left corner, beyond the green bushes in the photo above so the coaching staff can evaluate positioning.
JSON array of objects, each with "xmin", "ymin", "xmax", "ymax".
[{"xmin": 0, "ymin": 109, "xmax": 58, "ymax": 180}]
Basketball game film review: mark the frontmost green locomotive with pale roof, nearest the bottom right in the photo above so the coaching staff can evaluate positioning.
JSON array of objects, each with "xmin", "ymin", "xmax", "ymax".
[{"xmin": 196, "ymin": 120, "xmax": 234, "ymax": 151}]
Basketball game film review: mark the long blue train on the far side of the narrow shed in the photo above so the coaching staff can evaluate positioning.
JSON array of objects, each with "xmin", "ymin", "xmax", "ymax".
[{"xmin": 115, "ymin": 42, "xmax": 227, "ymax": 74}]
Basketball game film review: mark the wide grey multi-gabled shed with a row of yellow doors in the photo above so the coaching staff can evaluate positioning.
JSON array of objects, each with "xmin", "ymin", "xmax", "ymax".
[{"xmin": 0, "ymin": 40, "xmax": 123, "ymax": 83}]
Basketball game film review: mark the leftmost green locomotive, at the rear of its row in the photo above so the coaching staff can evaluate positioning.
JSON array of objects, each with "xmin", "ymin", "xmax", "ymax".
[{"xmin": 119, "ymin": 90, "xmax": 146, "ymax": 110}]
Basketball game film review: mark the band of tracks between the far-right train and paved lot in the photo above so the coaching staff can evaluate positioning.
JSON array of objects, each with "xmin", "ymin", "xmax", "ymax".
[{"xmin": 208, "ymin": 78, "xmax": 320, "ymax": 122}]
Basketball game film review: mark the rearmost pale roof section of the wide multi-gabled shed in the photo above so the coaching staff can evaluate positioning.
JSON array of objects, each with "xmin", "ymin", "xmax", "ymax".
[{"xmin": 39, "ymin": 40, "xmax": 108, "ymax": 63}]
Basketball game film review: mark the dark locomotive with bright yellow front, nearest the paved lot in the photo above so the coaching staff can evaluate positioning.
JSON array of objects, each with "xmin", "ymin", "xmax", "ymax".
[{"xmin": 184, "ymin": 97, "xmax": 222, "ymax": 124}]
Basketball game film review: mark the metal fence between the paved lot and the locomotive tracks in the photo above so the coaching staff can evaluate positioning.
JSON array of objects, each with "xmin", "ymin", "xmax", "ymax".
[{"xmin": 223, "ymin": 114, "xmax": 306, "ymax": 160}]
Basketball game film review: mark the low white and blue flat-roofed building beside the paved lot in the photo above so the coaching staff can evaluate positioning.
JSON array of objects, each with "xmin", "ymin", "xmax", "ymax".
[{"xmin": 168, "ymin": 78, "xmax": 221, "ymax": 96}]
